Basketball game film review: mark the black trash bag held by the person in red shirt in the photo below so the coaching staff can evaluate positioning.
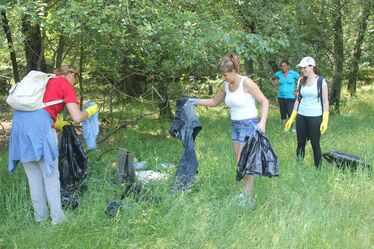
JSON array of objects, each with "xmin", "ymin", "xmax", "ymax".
[{"xmin": 58, "ymin": 125, "xmax": 87, "ymax": 208}]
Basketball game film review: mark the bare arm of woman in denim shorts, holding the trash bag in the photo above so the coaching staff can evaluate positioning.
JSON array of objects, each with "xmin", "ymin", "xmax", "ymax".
[{"xmin": 244, "ymin": 78, "xmax": 269, "ymax": 132}]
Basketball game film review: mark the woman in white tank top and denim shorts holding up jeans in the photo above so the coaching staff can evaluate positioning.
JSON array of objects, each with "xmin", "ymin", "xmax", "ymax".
[{"xmin": 190, "ymin": 54, "xmax": 269, "ymax": 207}]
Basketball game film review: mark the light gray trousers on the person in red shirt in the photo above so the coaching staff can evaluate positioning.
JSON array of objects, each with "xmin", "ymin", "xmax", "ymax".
[{"xmin": 23, "ymin": 158, "xmax": 66, "ymax": 225}]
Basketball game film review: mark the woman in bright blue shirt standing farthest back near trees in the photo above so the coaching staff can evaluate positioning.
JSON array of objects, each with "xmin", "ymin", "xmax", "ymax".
[{"xmin": 273, "ymin": 60, "xmax": 300, "ymax": 130}]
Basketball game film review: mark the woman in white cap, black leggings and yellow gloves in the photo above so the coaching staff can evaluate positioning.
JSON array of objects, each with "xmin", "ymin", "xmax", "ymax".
[{"xmin": 285, "ymin": 57, "xmax": 329, "ymax": 168}]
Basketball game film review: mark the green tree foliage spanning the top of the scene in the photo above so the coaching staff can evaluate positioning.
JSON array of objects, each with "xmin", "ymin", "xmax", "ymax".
[{"xmin": 0, "ymin": 0, "xmax": 374, "ymax": 93}]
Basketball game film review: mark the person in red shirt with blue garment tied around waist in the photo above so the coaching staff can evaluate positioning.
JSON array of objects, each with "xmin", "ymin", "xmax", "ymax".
[{"xmin": 8, "ymin": 66, "xmax": 97, "ymax": 224}]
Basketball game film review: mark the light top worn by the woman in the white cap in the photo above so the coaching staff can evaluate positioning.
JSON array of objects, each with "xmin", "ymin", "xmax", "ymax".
[{"xmin": 298, "ymin": 77, "xmax": 327, "ymax": 117}]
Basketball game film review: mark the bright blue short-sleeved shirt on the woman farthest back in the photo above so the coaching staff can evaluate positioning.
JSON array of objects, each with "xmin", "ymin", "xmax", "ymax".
[{"xmin": 274, "ymin": 70, "xmax": 300, "ymax": 99}]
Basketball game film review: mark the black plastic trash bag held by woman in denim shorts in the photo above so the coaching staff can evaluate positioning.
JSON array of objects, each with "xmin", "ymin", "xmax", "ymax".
[{"xmin": 236, "ymin": 130, "xmax": 279, "ymax": 181}]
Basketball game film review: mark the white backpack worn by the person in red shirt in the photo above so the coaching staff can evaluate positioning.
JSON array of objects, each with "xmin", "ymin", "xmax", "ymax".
[{"xmin": 6, "ymin": 70, "xmax": 64, "ymax": 111}]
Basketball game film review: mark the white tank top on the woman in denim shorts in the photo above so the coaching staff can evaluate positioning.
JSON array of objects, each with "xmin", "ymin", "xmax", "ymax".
[{"xmin": 225, "ymin": 77, "xmax": 258, "ymax": 120}]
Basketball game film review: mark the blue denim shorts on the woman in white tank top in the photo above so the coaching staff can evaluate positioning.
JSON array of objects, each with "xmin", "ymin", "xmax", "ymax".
[{"xmin": 231, "ymin": 118, "xmax": 258, "ymax": 144}]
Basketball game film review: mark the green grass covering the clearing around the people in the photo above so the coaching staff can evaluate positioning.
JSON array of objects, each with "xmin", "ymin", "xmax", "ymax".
[{"xmin": 0, "ymin": 89, "xmax": 374, "ymax": 248}]
